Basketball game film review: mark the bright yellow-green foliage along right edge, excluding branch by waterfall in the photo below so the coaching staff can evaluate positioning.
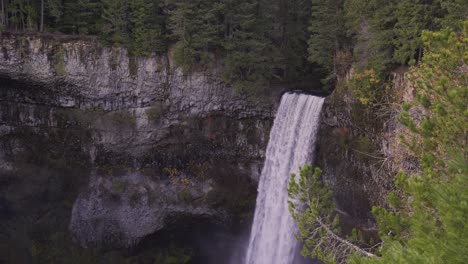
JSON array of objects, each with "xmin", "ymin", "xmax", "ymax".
[{"xmin": 351, "ymin": 22, "xmax": 468, "ymax": 263}]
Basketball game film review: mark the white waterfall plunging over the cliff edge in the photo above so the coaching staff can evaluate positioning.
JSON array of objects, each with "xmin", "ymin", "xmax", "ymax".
[{"xmin": 245, "ymin": 93, "xmax": 323, "ymax": 264}]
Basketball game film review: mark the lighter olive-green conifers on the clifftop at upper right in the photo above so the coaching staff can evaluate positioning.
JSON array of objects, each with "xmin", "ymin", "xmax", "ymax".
[{"xmin": 344, "ymin": 0, "xmax": 468, "ymax": 75}]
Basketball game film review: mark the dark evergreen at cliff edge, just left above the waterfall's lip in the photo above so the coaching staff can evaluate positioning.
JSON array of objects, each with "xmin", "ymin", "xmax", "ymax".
[{"xmin": 223, "ymin": 0, "xmax": 278, "ymax": 93}]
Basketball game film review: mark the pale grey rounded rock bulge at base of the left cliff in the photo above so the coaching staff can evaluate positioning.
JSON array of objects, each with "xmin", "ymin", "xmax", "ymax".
[{"xmin": 70, "ymin": 174, "xmax": 221, "ymax": 248}]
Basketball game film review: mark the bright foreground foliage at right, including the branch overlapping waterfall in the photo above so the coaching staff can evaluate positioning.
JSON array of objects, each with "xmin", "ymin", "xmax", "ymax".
[{"xmin": 289, "ymin": 21, "xmax": 468, "ymax": 263}]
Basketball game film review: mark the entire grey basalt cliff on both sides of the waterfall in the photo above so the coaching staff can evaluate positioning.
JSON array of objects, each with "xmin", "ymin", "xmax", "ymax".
[{"xmin": 0, "ymin": 34, "xmax": 410, "ymax": 263}]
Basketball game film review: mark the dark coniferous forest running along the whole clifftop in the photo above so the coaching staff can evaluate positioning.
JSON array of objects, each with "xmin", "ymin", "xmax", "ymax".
[{"xmin": 0, "ymin": 0, "xmax": 467, "ymax": 90}]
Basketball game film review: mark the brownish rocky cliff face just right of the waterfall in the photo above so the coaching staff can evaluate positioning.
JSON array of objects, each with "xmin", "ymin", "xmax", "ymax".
[{"xmin": 317, "ymin": 70, "xmax": 418, "ymax": 231}]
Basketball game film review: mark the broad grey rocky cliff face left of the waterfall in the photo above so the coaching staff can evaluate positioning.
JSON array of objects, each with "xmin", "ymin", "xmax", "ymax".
[{"xmin": 0, "ymin": 32, "xmax": 276, "ymax": 258}]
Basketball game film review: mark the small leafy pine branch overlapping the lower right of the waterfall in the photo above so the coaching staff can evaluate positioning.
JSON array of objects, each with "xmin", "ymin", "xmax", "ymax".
[{"xmin": 288, "ymin": 165, "xmax": 374, "ymax": 263}]
